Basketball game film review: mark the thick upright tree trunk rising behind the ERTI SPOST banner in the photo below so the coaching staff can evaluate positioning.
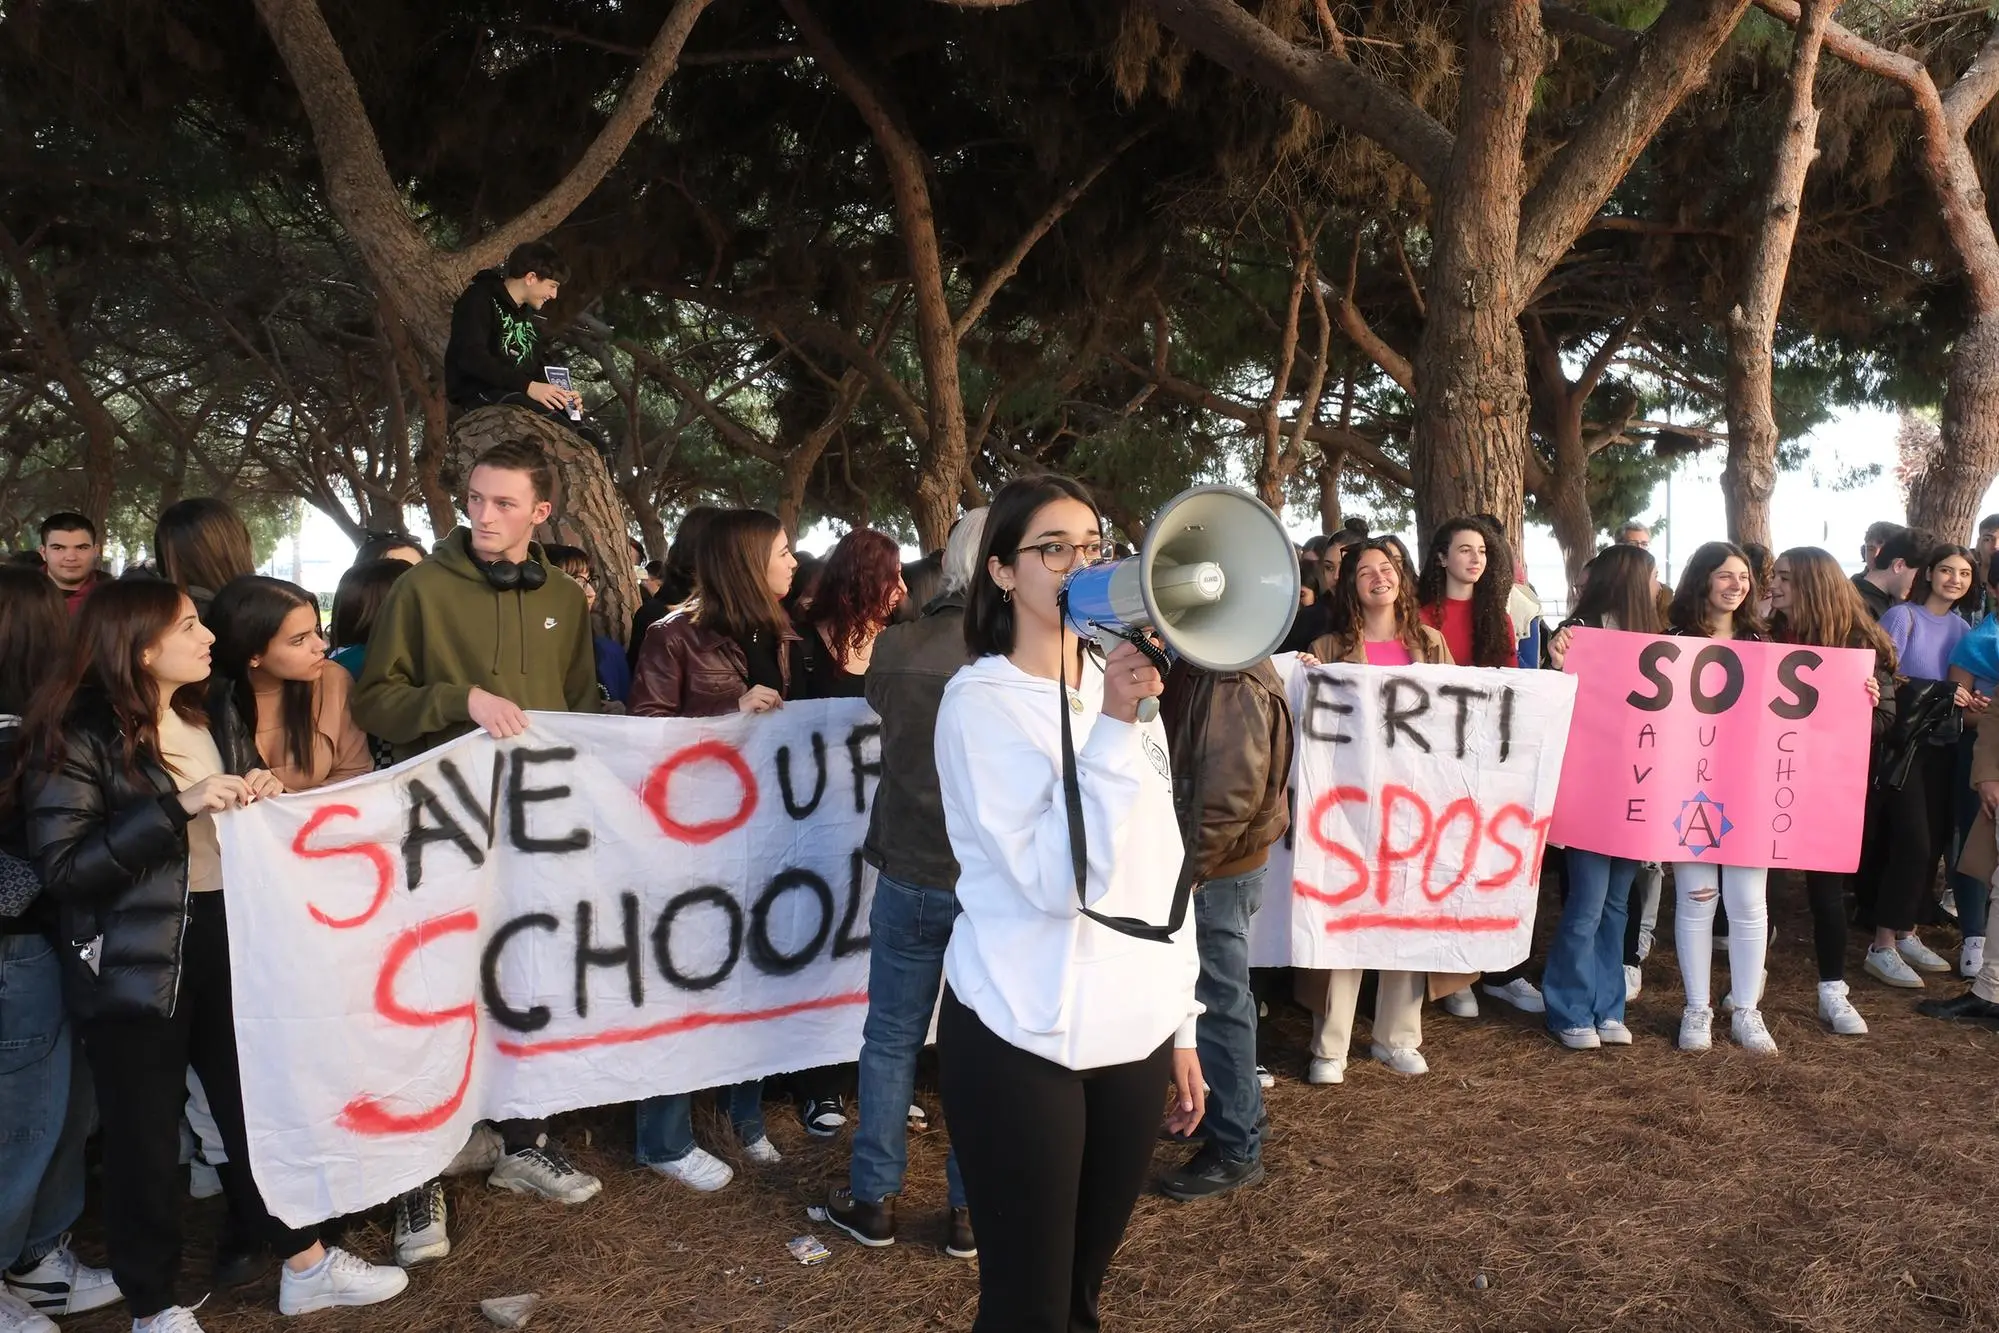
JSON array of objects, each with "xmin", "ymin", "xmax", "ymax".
[{"xmin": 1411, "ymin": 0, "xmax": 1545, "ymax": 550}]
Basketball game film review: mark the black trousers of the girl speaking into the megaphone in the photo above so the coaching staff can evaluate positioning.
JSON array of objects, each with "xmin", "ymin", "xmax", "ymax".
[{"xmin": 938, "ymin": 987, "xmax": 1173, "ymax": 1333}]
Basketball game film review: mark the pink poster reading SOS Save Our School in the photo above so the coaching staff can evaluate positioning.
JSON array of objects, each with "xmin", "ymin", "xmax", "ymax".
[{"xmin": 1549, "ymin": 630, "xmax": 1873, "ymax": 871}]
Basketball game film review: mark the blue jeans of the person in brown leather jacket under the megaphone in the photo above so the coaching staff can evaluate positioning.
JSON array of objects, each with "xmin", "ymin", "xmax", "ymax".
[{"xmin": 1193, "ymin": 865, "xmax": 1269, "ymax": 1161}]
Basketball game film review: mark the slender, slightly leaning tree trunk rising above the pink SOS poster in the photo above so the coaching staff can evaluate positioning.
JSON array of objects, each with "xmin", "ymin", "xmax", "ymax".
[{"xmin": 1721, "ymin": 0, "xmax": 1835, "ymax": 546}]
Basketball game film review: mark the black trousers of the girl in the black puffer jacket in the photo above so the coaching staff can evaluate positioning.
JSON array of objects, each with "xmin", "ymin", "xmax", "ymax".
[{"xmin": 78, "ymin": 893, "xmax": 316, "ymax": 1319}]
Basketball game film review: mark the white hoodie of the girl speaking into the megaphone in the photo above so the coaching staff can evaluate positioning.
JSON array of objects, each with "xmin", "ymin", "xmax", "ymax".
[{"xmin": 938, "ymin": 656, "xmax": 1201, "ymax": 1069}]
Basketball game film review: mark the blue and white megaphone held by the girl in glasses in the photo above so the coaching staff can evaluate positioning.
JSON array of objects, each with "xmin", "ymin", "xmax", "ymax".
[{"xmin": 1061, "ymin": 486, "xmax": 1297, "ymax": 721}]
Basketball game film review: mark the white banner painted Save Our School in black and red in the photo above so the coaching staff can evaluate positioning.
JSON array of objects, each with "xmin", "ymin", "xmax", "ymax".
[{"xmin": 220, "ymin": 699, "xmax": 880, "ymax": 1227}]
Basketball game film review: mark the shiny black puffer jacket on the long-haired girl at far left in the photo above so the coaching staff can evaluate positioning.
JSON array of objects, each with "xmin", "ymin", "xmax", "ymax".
[{"xmin": 26, "ymin": 687, "xmax": 262, "ymax": 1019}]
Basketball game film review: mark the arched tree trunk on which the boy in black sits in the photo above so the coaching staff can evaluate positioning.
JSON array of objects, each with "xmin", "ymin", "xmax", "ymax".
[{"xmin": 440, "ymin": 406, "xmax": 640, "ymax": 644}]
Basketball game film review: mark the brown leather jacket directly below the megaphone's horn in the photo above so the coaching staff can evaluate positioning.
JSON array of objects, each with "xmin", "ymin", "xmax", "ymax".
[{"xmin": 1159, "ymin": 658, "xmax": 1291, "ymax": 883}]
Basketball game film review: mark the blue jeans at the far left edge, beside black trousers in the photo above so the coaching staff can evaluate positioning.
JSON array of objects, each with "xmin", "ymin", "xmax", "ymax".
[{"xmin": 0, "ymin": 935, "xmax": 96, "ymax": 1267}]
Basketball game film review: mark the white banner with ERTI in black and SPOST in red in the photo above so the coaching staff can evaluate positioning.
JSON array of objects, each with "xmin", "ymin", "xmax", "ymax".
[{"xmin": 1249, "ymin": 658, "xmax": 1575, "ymax": 973}]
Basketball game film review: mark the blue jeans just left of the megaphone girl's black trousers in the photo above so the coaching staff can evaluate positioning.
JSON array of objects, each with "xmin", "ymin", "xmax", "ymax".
[{"xmin": 848, "ymin": 875, "xmax": 966, "ymax": 1207}]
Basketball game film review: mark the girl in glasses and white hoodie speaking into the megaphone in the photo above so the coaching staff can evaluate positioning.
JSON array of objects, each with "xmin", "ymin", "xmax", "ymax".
[{"xmin": 936, "ymin": 476, "xmax": 1205, "ymax": 1329}]
